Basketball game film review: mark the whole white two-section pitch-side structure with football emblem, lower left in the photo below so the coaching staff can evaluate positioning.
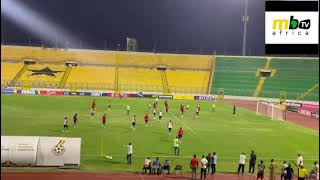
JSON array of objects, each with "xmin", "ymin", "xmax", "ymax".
[{"xmin": 1, "ymin": 136, "xmax": 81, "ymax": 167}]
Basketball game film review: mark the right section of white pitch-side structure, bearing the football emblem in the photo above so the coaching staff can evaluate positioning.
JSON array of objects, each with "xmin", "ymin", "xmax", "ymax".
[{"xmin": 37, "ymin": 137, "xmax": 81, "ymax": 166}]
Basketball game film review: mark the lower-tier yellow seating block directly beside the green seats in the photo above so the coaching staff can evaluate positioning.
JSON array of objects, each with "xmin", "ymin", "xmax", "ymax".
[{"xmin": 166, "ymin": 70, "xmax": 210, "ymax": 94}]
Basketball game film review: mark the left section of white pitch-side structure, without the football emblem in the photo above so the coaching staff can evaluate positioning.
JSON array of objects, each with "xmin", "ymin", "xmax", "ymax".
[{"xmin": 1, "ymin": 136, "xmax": 39, "ymax": 166}]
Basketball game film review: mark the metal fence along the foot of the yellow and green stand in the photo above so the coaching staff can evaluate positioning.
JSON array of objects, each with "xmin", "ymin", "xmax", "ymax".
[{"xmin": 1, "ymin": 80, "xmax": 319, "ymax": 101}]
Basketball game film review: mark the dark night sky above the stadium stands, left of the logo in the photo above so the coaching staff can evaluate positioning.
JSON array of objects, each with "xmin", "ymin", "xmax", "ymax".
[{"xmin": 1, "ymin": 0, "xmax": 264, "ymax": 55}]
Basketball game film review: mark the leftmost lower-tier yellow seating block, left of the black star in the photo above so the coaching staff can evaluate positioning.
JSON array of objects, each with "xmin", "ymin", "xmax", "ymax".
[{"xmin": 1, "ymin": 62, "xmax": 23, "ymax": 80}]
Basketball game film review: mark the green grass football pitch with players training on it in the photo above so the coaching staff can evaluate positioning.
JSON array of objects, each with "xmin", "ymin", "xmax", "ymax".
[{"xmin": 1, "ymin": 95, "xmax": 319, "ymax": 172}]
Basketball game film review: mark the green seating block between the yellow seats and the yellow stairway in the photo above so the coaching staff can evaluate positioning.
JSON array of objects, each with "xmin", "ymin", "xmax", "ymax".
[{"xmin": 211, "ymin": 57, "xmax": 266, "ymax": 96}]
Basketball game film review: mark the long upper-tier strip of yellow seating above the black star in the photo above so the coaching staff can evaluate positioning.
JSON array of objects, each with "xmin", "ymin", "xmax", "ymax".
[{"xmin": 1, "ymin": 46, "xmax": 213, "ymax": 70}]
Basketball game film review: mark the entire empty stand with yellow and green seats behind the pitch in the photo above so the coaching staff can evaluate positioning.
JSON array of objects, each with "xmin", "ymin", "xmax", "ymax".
[{"xmin": 1, "ymin": 45, "xmax": 319, "ymax": 101}]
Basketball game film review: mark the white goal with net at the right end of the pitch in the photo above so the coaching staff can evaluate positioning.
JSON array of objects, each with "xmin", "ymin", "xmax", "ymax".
[{"xmin": 256, "ymin": 100, "xmax": 285, "ymax": 120}]
